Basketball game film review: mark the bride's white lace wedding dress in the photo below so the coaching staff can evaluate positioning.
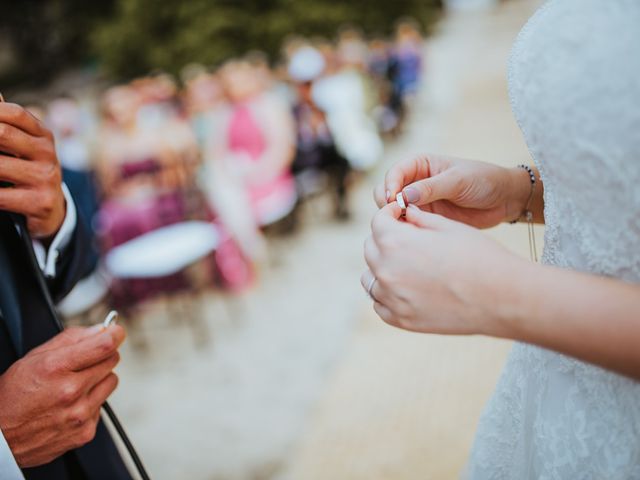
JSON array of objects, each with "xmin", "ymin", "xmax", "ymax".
[{"xmin": 466, "ymin": 0, "xmax": 640, "ymax": 480}]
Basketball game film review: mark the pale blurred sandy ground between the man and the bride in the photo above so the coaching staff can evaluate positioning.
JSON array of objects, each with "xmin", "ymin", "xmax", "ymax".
[{"xmin": 112, "ymin": 0, "xmax": 541, "ymax": 480}]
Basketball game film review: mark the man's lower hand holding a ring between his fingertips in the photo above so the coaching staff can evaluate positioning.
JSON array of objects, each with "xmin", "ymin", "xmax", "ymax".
[{"xmin": 0, "ymin": 325, "xmax": 125, "ymax": 468}]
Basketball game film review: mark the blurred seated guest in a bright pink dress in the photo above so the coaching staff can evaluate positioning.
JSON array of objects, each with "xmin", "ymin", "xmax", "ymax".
[{"xmin": 206, "ymin": 61, "xmax": 297, "ymax": 258}]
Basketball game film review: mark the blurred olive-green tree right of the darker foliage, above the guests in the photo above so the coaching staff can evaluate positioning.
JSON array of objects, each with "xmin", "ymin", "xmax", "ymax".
[{"xmin": 92, "ymin": 0, "xmax": 441, "ymax": 79}]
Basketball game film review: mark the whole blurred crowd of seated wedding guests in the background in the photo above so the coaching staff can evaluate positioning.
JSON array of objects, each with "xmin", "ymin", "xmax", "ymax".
[{"xmin": 32, "ymin": 21, "xmax": 422, "ymax": 316}]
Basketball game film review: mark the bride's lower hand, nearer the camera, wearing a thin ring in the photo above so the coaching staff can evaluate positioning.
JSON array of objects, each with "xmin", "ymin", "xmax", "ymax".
[{"xmin": 361, "ymin": 203, "xmax": 526, "ymax": 336}]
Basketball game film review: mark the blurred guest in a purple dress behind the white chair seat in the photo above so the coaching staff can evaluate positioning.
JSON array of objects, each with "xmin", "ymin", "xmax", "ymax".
[{"xmin": 97, "ymin": 86, "xmax": 189, "ymax": 312}]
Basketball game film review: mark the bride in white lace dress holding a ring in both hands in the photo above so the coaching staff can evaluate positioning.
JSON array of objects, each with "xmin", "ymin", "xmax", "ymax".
[{"xmin": 362, "ymin": 0, "xmax": 640, "ymax": 480}]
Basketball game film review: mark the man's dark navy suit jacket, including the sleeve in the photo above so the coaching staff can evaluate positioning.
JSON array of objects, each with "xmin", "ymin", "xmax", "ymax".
[{"xmin": 0, "ymin": 207, "xmax": 131, "ymax": 480}]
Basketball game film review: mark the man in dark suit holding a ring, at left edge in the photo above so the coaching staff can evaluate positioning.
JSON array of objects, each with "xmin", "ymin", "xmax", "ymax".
[{"xmin": 0, "ymin": 103, "xmax": 131, "ymax": 480}]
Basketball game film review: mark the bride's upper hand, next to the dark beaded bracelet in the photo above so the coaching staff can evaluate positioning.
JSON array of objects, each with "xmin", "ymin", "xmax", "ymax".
[{"xmin": 374, "ymin": 155, "xmax": 530, "ymax": 228}]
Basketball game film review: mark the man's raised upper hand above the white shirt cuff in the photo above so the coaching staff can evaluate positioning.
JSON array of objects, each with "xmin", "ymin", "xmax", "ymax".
[{"xmin": 0, "ymin": 103, "xmax": 66, "ymax": 241}]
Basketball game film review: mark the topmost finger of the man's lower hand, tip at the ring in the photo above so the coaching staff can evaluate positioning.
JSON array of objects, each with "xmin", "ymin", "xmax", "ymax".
[{"xmin": 60, "ymin": 325, "xmax": 125, "ymax": 371}]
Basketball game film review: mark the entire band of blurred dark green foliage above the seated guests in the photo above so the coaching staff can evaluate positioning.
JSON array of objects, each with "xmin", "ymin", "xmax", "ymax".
[{"xmin": 0, "ymin": 0, "xmax": 442, "ymax": 86}]
